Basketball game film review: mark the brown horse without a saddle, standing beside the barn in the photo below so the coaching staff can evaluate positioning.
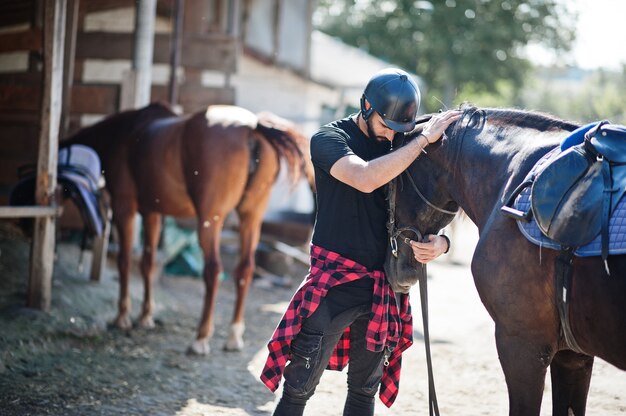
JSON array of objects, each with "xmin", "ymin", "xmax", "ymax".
[{"xmin": 62, "ymin": 104, "xmax": 313, "ymax": 354}]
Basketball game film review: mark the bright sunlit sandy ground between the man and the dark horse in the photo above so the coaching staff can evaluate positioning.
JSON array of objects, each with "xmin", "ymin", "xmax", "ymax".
[{"xmin": 260, "ymin": 220, "xmax": 626, "ymax": 416}]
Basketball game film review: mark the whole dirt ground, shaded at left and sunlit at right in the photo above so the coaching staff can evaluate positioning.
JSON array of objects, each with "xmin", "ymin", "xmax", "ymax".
[{"xmin": 0, "ymin": 219, "xmax": 626, "ymax": 416}]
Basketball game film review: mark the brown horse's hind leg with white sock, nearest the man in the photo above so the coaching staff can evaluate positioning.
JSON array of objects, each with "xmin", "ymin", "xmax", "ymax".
[{"xmin": 224, "ymin": 209, "xmax": 265, "ymax": 351}]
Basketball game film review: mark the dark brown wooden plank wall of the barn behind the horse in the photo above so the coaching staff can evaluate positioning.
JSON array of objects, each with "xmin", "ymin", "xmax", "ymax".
[{"xmin": 0, "ymin": 0, "xmax": 237, "ymax": 205}]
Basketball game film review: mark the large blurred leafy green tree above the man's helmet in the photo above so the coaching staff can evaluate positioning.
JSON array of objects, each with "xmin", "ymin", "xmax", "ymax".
[{"xmin": 315, "ymin": 0, "xmax": 575, "ymax": 110}]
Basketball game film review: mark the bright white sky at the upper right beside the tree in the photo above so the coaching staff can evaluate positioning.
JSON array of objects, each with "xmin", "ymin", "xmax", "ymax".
[{"xmin": 529, "ymin": 0, "xmax": 626, "ymax": 69}]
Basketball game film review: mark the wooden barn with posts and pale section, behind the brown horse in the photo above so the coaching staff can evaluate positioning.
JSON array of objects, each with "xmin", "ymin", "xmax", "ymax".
[{"xmin": 0, "ymin": 0, "xmax": 422, "ymax": 309}]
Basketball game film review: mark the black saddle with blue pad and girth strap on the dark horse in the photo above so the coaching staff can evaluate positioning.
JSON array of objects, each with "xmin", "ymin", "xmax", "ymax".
[{"xmin": 501, "ymin": 121, "xmax": 626, "ymax": 354}]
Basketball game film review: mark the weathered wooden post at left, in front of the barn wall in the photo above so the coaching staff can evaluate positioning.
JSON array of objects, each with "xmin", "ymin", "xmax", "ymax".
[{"xmin": 28, "ymin": 0, "xmax": 67, "ymax": 310}]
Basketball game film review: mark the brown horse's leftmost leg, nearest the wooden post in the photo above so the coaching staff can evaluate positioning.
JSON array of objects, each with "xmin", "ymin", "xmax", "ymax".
[{"xmin": 113, "ymin": 210, "xmax": 135, "ymax": 329}]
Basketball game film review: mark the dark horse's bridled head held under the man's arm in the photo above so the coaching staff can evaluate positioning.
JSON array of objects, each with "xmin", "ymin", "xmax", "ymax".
[{"xmin": 385, "ymin": 118, "xmax": 458, "ymax": 293}]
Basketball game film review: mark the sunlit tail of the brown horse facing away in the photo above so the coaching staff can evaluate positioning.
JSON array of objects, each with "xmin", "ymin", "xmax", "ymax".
[{"xmin": 255, "ymin": 112, "xmax": 315, "ymax": 190}]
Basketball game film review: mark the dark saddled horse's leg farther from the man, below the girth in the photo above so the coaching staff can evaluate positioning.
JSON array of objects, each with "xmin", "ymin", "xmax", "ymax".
[{"xmin": 550, "ymin": 350, "xmax": 593, "ymax": 416}]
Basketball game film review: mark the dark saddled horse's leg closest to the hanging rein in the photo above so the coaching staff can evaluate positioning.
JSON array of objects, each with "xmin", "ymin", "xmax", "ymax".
[{"xmin": 496, "ymin": 330, "xmax": 551, "ymax": 416}]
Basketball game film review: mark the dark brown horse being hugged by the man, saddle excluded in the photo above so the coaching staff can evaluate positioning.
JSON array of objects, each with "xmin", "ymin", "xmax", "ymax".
[{"xmin": 386, "ymin": 108, "xmax": 626, "ymax": 416}]
